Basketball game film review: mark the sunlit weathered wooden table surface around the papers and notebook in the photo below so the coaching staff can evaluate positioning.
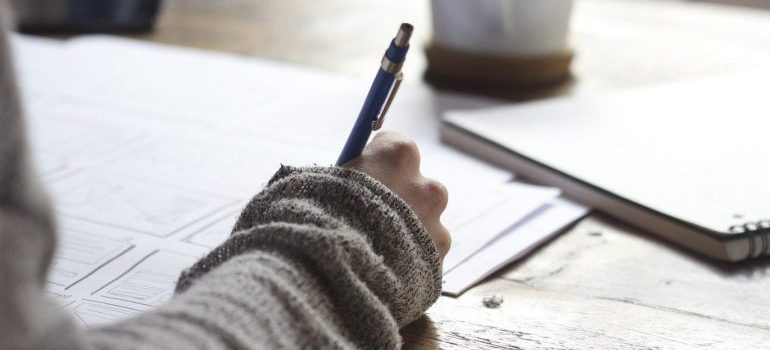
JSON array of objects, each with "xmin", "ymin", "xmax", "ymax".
[{"xmin": 132, "ymin": 0, "xmax": 770, "ymax": 349}]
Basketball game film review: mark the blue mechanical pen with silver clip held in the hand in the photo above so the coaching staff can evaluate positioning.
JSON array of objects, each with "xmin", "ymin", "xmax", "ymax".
[{"xmin": 337, "ymin": 23, "xmax": 413, "ymax": 166}]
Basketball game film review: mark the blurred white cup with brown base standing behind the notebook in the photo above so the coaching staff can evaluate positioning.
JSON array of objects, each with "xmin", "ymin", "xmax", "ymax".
[{"xmin": 426, "ymin": 0, "xmax": 573, "ymax": 87}]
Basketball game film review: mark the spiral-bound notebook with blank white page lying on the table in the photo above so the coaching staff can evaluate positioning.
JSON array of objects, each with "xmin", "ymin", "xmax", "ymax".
[{"xmin": 442, "ymin": 71, "xmax": 770, "ymax": 261}]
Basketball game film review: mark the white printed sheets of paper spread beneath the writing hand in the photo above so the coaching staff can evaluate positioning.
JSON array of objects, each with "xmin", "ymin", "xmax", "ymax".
[{"xmin": 14, "ymin": 37, "xmax": 585, "ymax": 326}]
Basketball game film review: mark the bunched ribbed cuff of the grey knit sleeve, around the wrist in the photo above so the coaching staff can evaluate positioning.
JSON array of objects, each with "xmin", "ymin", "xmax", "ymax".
[{"xmin": 177, "ymin": 166, "xmax": 441, "ymax": 326}]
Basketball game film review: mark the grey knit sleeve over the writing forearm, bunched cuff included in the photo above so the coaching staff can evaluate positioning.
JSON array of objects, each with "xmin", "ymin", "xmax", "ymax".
[{"xmin": 85, "ymin": 167, "xmax": 441, "ymax": 349}]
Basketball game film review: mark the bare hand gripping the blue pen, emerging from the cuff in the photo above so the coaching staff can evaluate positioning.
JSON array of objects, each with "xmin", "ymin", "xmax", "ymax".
[{"xmin": 344, "ymin": 132, "xmax": 452, "ymax": 260}]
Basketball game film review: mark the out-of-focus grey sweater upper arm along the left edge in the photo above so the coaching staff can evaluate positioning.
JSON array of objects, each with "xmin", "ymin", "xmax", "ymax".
[{"xmin": 0, "ymin": 0, "xmax": 86, "ymax": 349}]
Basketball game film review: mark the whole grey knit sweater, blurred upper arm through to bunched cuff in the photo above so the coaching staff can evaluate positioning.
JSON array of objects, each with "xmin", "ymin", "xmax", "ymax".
[{"xmin": 0, "ymin": 4, "xmax": 441, "ymax": 349}]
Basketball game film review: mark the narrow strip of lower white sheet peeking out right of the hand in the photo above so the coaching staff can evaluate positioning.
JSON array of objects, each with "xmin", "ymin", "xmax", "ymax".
[{"xmin": 442, "ymin": 197, "xmax": 588, "ymax": 295}]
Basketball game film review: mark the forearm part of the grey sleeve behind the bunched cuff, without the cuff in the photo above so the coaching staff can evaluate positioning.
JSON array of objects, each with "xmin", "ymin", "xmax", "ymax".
[{"xmin": 88, "ymin": 251, "xmax": 370, "ymax": 349}]
